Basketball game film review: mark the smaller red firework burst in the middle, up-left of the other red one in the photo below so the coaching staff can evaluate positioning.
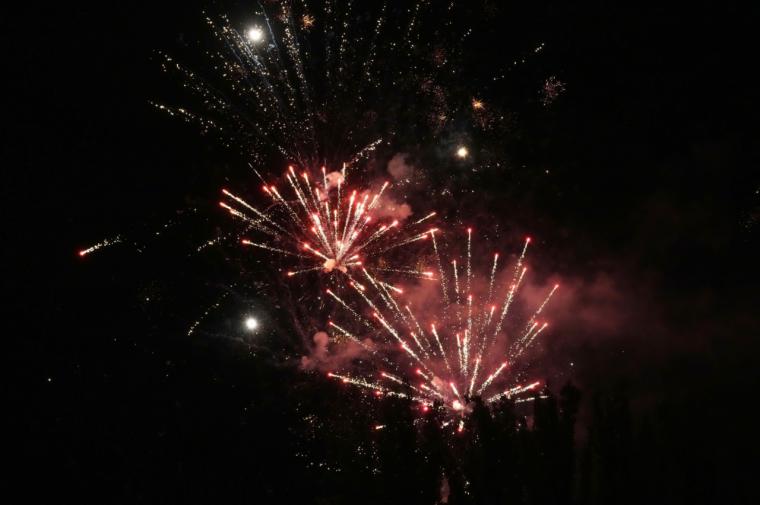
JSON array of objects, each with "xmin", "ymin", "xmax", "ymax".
[{"xmin": 220, "ymin": 165, "xmax": 435, "ymax": 278}]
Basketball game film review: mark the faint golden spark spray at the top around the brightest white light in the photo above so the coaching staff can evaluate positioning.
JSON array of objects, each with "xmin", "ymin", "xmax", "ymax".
[{"xmin": 154, "ymin": 0, "xmax": 452, "ymax": 166}]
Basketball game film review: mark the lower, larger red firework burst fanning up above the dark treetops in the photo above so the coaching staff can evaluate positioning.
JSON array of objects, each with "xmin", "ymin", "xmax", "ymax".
[{"xmin": 330, "ymin": 229, "xmax": 558, "ymax": 428}]
